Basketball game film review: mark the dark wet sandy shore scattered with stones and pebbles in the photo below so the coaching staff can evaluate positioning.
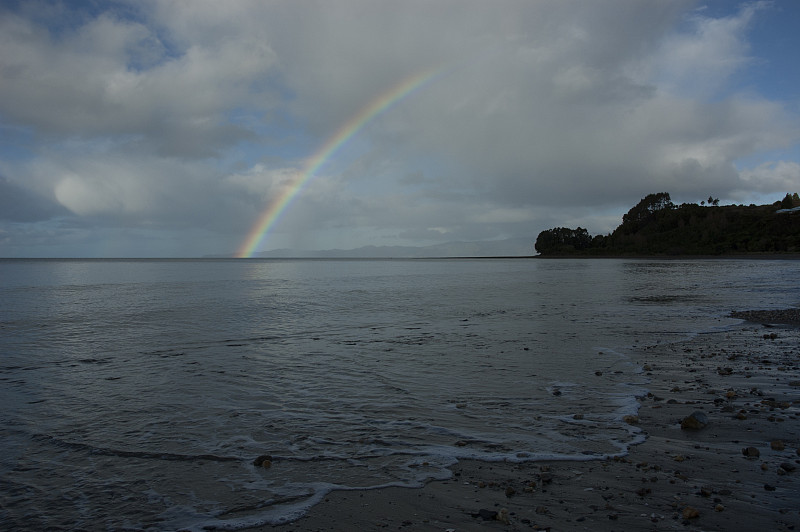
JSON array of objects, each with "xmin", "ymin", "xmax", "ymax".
[{"xmin": 264, "ymin": 314, "xmax": 800, "ymax": 532}]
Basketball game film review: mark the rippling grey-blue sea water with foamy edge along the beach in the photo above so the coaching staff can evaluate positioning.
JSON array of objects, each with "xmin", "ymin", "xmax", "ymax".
[{"xmin": 0, "ymin": 259, "xmax": 800, "ymax": 530}]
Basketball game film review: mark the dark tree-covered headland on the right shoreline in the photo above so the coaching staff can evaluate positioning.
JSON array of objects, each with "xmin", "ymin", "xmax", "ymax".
[{"xmin": 536, "ymin": 192, "xmax": 800, "ymax": 257}]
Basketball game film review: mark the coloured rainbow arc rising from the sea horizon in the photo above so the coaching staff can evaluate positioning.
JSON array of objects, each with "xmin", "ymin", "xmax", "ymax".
[{"xmin": 235, "ymin": 70, "xmax": 437, "ymax": 258}]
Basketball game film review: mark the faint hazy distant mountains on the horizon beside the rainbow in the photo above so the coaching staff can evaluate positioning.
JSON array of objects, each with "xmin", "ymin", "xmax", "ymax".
[{"xmin": 253, "ymin": 238, "xmax": 534, "ymax": 259}]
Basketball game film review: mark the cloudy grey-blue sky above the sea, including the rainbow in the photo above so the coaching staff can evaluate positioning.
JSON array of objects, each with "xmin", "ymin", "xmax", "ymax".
[{"xmin": 0, "ymin": 0, "xmax": 800, "ymax": 257}]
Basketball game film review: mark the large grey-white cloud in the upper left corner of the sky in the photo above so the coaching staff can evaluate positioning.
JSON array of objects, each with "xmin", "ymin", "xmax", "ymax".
[{"xmin": 0, "ymin": 4, "xmax": 275, "ymax": 157}]
